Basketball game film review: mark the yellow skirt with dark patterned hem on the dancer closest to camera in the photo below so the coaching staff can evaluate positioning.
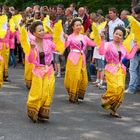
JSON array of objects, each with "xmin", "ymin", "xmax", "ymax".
[{"xmin": 27, "ymin": 72, "xmax": 55, "ymax": 121}]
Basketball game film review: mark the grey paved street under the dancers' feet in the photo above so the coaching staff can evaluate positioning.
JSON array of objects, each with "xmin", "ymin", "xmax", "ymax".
[{"xmin": 0, "ymin": 66, "xmax": 140, "ymax": 140}]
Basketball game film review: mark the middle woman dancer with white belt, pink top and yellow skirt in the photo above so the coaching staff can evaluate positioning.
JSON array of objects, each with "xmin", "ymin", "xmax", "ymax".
[{"xmin": 64, "ymin": 18, "xmax": 95, "ymax": 103}]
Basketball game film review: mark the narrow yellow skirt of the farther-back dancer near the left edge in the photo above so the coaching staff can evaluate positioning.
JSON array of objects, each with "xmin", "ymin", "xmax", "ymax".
[{"xmin": 1, "ymin": 43, "xmax": 10, "ymax": 79}]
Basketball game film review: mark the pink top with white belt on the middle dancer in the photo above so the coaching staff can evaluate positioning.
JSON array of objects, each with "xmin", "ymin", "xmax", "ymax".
[{"xmin": 65, "ymin": 34, "xmax": 96, "ymax": 65}]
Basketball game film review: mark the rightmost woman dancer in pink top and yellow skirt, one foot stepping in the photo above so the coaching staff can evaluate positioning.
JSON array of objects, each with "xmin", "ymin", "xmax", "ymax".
[{"xmin": 99, "ymin": 26, "xmax": 137, "ymax": 117}]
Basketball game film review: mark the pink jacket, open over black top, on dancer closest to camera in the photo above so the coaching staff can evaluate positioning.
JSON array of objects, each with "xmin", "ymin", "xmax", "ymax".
[{"xmin": 28, "ymin": 39, "xmax": 55, "ymax": 78}]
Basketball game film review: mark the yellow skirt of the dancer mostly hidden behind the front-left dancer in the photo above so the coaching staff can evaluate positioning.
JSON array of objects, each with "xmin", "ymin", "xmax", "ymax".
[{"xmin": 24, "ymin": 60, "xmax": 34, "ymax": 89}]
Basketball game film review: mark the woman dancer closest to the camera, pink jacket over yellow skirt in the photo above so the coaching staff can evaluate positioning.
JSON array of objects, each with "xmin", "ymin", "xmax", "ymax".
[{"xmin": 27, "ymin": 21, "xmax": 55, "ymax": 122}]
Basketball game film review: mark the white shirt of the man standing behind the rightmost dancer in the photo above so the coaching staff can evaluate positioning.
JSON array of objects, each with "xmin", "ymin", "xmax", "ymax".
[{"xmin": 108, "ymin": 18, "xmax": 125, "ymax": 40}]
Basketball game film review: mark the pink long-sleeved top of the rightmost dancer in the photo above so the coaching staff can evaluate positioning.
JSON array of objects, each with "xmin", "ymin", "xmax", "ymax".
[{"xmin": 99, "ymin": 41, "xmax": 137, "ymax": 74}]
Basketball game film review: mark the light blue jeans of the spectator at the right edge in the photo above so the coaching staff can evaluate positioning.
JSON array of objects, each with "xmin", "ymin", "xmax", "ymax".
[{"xmin": 128, "ymin": 54, "xmax": 140, "ymax": 92}]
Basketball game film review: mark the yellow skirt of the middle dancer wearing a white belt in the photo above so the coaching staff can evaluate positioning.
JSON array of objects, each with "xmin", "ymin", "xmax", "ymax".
[{"xmin": 64, "ymin": 55, "xmax": 88, "ymax": 102}]
